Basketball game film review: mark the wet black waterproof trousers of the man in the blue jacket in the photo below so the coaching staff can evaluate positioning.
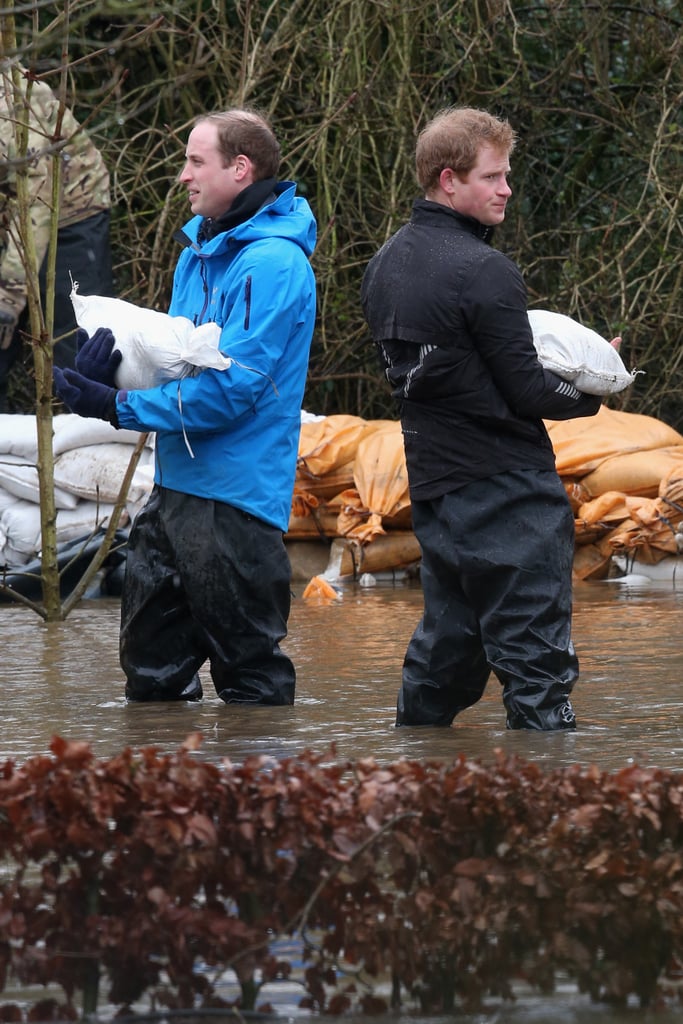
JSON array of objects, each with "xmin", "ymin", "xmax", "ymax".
[{"xmin": 120, "ymin": 486, "xmax": 295, "ymax": 705}]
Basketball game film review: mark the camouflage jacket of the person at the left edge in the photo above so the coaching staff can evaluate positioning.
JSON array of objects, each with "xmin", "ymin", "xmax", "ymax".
[{"xmin": 0, "ymin": 62, "xmax": 111, "ymax": 317}]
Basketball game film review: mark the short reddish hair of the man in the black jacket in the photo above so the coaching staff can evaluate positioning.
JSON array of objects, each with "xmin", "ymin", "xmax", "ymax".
[{"xmin": 415, "ymin": 106, "xmax": 516, "ymax": 193}]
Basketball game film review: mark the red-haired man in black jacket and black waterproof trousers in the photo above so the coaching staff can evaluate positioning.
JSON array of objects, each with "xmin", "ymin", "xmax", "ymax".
[{"xmin": 361, "ymin": 108, "xmax": 600, "ymax": 730}]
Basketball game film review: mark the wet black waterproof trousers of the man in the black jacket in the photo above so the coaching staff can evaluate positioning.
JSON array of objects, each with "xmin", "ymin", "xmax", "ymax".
[{"xmin": 396, "ymin": 470, "xmax": 579, "ymax": 729}]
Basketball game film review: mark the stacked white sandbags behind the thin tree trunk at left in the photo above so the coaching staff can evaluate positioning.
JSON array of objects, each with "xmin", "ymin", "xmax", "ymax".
[{"xmin": 0, "ymin": 414, "xmax": 154, "ymax": 569}]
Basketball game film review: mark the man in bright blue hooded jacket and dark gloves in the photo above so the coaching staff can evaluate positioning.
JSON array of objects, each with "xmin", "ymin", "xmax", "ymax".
[{"xmin": 54, "ymin": 110, "xmax": 315, "ymax": 705}]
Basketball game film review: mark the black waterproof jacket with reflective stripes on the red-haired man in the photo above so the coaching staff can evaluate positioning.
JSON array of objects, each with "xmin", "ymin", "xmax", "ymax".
[{"xmin": 361, "ymin": 200, "xmax": 601, "ymax": 501}]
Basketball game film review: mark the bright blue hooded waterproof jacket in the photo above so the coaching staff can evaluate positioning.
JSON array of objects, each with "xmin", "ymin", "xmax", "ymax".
[{"xmin": 117, "ymin": 181, "xmax": 315, "ymax": 530}]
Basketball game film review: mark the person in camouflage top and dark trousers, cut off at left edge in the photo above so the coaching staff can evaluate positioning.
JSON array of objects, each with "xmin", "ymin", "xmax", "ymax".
[{"xmin": 0, "ymin": 60, "xmax": 113, "ymax": 413}]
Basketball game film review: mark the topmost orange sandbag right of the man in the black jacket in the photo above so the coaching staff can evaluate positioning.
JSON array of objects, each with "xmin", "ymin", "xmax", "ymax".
[{"xmin": 546, "ymin": 406, "xmax": 683, "ymax": 482}]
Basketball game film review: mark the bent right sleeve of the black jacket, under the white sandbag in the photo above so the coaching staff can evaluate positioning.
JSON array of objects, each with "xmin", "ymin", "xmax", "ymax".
[{"xmin": 464, "ymin": 250, "xmax": 602, "ymax": 420}]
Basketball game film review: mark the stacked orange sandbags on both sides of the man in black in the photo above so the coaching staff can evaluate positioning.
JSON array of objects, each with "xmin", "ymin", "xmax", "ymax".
[{"xmin": 288, "ymin": 406, "xmax": 683, "ymax": 579}]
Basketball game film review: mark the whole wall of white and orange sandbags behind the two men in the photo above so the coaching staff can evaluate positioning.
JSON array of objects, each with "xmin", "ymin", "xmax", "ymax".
[{"xmin": 6, "ymin": 406, "xmax": 683, "ymax": 579}]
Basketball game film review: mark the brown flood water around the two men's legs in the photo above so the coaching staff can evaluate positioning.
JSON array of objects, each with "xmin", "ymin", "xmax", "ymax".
[{"xmin": 0, "ymin": 582, "xmax": 683, "ymax": 1024}]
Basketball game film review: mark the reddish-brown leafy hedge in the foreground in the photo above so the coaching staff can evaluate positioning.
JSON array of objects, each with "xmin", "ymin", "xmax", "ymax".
[{"xmin": 0, "ymin": 735, "xmax": 683, "ymax": 1020}]
